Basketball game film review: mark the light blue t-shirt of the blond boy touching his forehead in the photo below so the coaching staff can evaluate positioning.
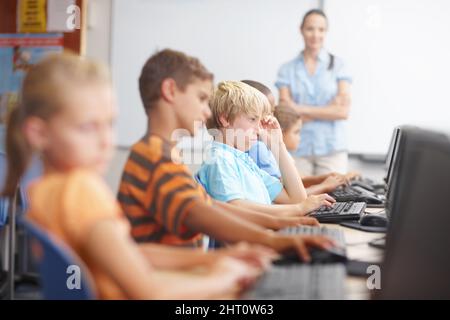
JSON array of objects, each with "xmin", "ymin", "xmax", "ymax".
[{"xmin": 197, "ymin": 142, "xmax": 283, "ymax": 204}]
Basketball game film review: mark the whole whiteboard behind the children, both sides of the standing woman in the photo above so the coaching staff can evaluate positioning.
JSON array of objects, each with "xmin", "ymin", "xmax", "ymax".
[{"xmin": 111, "ymin": 0, "xmax": 450, "ymax": 154}]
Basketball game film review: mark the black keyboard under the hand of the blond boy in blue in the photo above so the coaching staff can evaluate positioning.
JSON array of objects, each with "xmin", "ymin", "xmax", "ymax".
[{"xmin": 310, "ymin": 201, "xmax": 366, "ymax": 223}]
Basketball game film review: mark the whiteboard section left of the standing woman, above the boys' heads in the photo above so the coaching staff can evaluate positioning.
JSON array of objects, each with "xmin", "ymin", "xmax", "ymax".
[{"xmin": 111, "ymin": 0, "xmax": 317, "ymax": 146}]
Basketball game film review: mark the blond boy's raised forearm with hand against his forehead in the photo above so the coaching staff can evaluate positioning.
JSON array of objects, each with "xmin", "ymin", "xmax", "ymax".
[{"xmin": 260, "ymin": 116, "xmax": 307, "ymax": 204}]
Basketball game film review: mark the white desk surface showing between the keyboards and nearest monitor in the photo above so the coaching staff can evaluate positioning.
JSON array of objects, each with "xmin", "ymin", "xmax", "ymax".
[{"xmin": 323, "ymin": 208, "xmax": 385, "ymax": 300}]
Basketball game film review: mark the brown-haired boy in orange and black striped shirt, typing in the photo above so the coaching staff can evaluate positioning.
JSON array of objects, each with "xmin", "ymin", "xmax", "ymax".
[{"xmin": 118, "ymin": 50, "xmax": 333, "ymax": 261}]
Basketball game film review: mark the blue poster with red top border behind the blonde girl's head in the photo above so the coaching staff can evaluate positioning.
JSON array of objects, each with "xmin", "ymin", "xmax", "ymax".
[{"xmin": 0, "ymin": 33, "xmax": 63, "ymax": 150}]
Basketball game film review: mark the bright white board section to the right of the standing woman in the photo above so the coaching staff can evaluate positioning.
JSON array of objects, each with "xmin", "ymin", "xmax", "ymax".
[{"xmin": 325, "ymin": 0, "xmax": 450, "ymax": 153}]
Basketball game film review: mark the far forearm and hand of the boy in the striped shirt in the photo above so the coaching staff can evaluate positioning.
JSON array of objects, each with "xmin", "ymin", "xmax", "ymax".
[{"xmin": 214, "ymin": 201, "xmax": 319, "ymax": 230}]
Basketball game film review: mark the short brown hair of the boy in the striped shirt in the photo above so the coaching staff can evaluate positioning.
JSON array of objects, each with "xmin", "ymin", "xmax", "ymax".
[{"xmin": 139, "ymin": 49, "xmax": 214, "ymax": 112}]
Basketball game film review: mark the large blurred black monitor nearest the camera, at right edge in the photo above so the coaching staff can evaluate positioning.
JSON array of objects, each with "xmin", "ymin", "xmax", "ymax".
[{"xmin": 377, "ymin": 127, "xmax": 450, "ymax": 299}]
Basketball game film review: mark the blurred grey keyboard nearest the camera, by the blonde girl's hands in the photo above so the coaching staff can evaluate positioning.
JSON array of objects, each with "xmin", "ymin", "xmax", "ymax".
[{"xmin": 244, "ymin": 264, "xmax": 346, "ymax": 300}]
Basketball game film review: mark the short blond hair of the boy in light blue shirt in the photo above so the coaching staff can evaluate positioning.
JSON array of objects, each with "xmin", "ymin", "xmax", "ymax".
[{"xmin": 206, "ymin": 81, "xmax": 271, "ymax": 129}]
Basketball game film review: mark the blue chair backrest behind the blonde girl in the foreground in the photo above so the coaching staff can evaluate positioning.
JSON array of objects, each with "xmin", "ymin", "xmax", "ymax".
[{"xmin": 19, "ymin": 219, "xmax": 96, "ymax": 300}]
